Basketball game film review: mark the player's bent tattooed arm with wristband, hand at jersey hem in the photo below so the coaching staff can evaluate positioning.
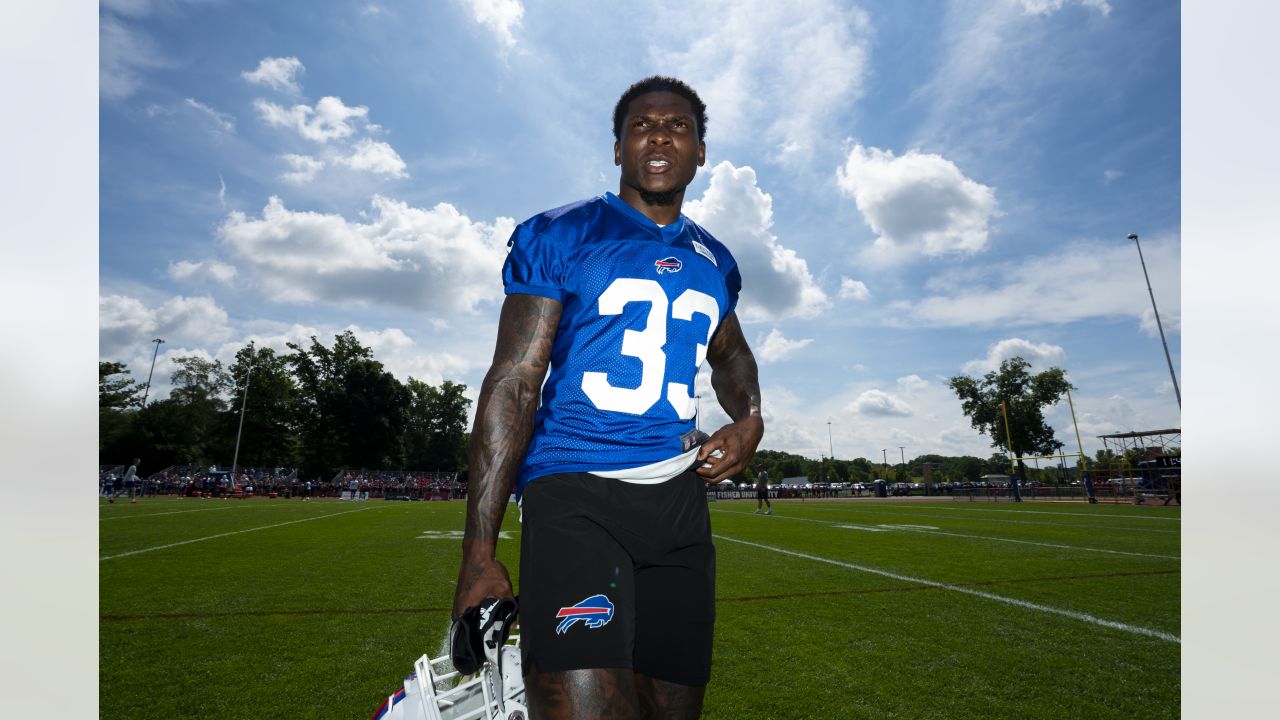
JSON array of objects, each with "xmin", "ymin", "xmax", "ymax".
[{"xmin": 696, "ymin": 313, "xmax": 764, "ymax": 483}]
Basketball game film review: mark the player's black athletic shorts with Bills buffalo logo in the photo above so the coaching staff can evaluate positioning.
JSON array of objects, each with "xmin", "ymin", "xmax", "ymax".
[{"xmin": 520, "ymin": 471, "xmax": 716, "ymax": 685}]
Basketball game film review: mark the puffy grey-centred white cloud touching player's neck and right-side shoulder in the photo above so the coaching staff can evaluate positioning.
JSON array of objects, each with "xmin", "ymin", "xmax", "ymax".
[{"xmin": 685, "ymin": 160, "xmax": 831, "ymax": 322}]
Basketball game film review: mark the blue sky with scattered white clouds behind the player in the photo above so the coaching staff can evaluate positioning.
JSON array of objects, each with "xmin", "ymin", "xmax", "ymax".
[{"xmin": 99, "ymin": 0, "xmax": 1181, "ymax": 464}]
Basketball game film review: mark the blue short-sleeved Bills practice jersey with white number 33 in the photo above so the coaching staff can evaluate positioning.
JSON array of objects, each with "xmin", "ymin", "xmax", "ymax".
[{"xmin": 502, "ymin": 192, "xmax": 742, "ymax": 497}]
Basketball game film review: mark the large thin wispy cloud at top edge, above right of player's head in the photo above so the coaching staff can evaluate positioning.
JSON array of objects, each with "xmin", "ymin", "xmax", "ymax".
[{"xmin": 649, "ymin": 0, "xmax": 872, "ymax": 161}]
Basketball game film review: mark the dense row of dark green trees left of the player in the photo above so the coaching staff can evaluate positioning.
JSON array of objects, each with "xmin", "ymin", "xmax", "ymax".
[{"xmin": 99, "ymin": 331, "xmax": 471, "ymax": 478}]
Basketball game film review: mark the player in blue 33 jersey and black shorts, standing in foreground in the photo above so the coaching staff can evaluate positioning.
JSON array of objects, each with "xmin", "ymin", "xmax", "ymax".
[{"xmin": 452, "ymin": 76, "xmax": 764, "ymax": 720}]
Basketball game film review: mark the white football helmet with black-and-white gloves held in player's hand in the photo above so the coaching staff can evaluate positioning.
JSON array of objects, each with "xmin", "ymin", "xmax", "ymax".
[{"xmin": 370, "ymin": 600, "xmax": 529, "ymax": 720}]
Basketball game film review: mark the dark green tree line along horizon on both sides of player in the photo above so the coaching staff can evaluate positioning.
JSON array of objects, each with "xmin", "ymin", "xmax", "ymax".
[{"xmin": 99, "ymin": 340, "xmax": 1139, "ymax": 483}]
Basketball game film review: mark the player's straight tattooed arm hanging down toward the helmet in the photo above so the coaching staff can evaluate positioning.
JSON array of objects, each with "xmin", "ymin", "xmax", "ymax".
[{"xmin": 453, "ymin": 295, "xmax": 561, "ymax": 618}]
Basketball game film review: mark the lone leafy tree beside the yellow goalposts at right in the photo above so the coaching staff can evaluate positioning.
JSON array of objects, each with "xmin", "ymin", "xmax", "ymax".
[{"xmin": 947, "ymin": 357, "xmax": 1073, "ymax": 480}]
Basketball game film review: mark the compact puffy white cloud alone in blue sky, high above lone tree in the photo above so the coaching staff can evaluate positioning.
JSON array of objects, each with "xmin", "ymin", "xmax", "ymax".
[{"xmin": 836, "ymin": 145, "xmax": 996, "ymax": 263}]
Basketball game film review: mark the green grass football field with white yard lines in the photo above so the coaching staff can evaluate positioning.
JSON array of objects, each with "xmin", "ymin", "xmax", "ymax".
[{"xmin": 99, "ymin": 498, "xmax": 1181, "ymax": 720}]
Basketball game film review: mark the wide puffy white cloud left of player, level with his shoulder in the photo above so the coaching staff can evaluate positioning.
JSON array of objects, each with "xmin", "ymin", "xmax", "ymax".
[{"xmin": 218, "ymin": 196, "xmax": 515, "ymax": 315}]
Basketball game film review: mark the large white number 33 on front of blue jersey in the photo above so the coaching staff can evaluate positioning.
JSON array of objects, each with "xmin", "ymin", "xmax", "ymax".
[{"xmin": 582, "ymin": 278, "xmax": 719, "ymax": 420}]
